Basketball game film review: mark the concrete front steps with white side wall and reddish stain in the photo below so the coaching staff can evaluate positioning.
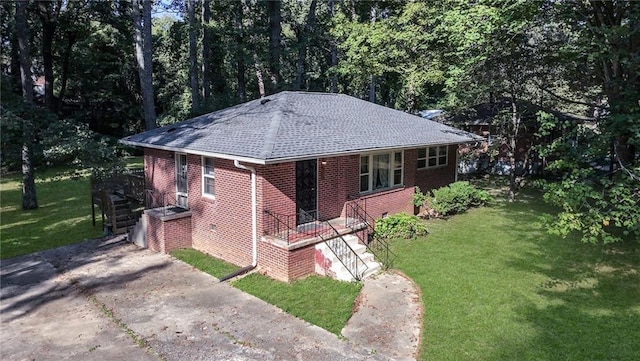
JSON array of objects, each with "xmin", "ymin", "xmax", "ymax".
[{"xmin": 315, "ymin": 234, "xmax": 382, "ymax": 282}]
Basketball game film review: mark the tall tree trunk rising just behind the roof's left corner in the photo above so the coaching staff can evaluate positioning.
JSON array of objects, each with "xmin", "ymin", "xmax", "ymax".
[{"xmin": 132, "ymin": 0, "xmax": 156, "ymax": 130}]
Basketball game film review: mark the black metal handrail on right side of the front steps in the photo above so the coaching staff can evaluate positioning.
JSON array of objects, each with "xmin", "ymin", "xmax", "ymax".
[{"xmin": 346, "ymin": 200, "xmax": 397, "ymax": 269}]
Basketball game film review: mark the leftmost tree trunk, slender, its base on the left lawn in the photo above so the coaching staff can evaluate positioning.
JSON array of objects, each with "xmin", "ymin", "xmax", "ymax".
[{"xmin": 16, "ymin": 0, "xmax": 38, "ymax": 210}]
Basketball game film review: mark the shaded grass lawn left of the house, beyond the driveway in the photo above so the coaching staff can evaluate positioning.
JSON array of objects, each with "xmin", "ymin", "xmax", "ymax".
[{"xmin": 0, "ymin": 157, "xmax": 141, "ymax": 259}]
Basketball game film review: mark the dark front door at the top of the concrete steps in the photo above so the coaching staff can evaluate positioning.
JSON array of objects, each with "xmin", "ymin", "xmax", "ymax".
[{"xmin": 296, "ymin": 159, "xmax": 318, "ymax": 224}]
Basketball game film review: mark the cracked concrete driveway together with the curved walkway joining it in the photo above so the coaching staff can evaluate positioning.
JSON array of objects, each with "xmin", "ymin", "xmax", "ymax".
[{"xmin": 0, "ymin": 237, "xmax": 421, "ymax": 360}]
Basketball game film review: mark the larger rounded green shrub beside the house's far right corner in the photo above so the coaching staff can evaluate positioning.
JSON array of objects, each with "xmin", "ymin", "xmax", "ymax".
[{"xmin": 428, "ymin": 182, "xmax": 491, "ymax": 216}]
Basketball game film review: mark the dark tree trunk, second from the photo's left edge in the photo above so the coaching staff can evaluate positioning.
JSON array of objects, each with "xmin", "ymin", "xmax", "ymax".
[{"xmin": 38, "ymin": 0, "xmax": 62, "ymax": 113}]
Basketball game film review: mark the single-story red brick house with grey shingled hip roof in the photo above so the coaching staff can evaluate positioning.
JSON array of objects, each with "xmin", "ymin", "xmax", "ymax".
[{"xmin": 122, "ymin": 92, "xmax": 474, "ymax": 281}]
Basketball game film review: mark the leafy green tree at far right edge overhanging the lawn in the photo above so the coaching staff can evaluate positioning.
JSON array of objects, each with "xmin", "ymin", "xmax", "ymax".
[{"xmin": 544, "ymin": 1, "xmax": 640, "ymax": 243}]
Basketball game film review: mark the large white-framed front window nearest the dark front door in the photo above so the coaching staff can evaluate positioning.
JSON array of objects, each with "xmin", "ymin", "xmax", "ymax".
[{"xmin": 360, "ymin": 152, "xmax": 403, "ymax": 192}]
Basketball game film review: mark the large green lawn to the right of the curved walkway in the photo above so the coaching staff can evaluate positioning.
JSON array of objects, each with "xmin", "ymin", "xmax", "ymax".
[{"xmin": 392, "ymin": 190, "xmax": 640, "ymax": 360}]
